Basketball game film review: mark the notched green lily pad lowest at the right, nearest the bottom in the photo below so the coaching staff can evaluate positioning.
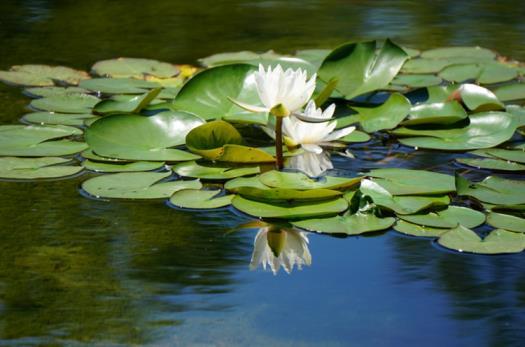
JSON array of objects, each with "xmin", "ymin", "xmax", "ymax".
[{"xmin": 438, "ymin": 225, "xmax": 525, "ymax": 254}]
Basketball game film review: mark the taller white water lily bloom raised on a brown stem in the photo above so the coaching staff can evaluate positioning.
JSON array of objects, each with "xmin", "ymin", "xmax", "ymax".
[{"xmin": 232, "ymin": 64, "xmax": 316, "ymax": 116}]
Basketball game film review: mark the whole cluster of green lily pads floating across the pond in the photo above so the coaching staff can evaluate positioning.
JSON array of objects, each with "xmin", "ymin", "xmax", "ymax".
[{"xmin": 0, "ymin": 40, "xmax": 525, "ymax": 254}]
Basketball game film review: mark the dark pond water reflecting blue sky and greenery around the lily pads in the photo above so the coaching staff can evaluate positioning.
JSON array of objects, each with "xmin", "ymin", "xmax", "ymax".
[{"xmin": 0, "ymin": 0, "xmax": 525, "ymax": 346}]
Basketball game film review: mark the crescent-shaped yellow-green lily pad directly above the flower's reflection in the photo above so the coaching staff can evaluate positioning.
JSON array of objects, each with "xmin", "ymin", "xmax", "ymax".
[{"xmin": 232, "ymin": 195, "xmax": 348, "ymax": 219}]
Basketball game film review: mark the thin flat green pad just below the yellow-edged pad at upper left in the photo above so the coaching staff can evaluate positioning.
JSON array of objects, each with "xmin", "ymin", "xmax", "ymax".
[{"xmin": 80, "ymin": 78, "xmax": 160, "ymax": 94}]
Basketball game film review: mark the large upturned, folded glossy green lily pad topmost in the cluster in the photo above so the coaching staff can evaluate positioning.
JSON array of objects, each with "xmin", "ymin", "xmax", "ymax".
[{"xmin": 318, "ymin": 40, "xmax": 408, "ymax": 99}]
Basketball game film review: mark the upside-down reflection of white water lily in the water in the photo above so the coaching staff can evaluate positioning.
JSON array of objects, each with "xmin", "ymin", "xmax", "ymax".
[{"xmin": 250, "ymin": 226, "xmax": 312, "ymax": 275}]
